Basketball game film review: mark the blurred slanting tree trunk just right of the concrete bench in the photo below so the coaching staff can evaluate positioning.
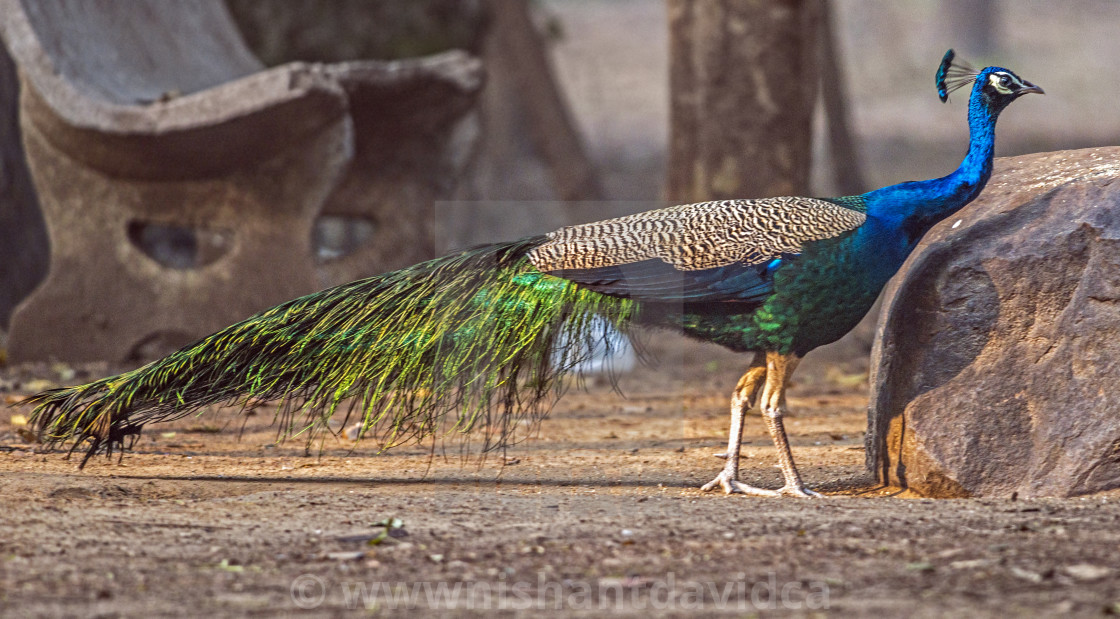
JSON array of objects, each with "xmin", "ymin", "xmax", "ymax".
[{"xmin": 445, "ymin": 0, "xmax": 606, "ymax": 248}]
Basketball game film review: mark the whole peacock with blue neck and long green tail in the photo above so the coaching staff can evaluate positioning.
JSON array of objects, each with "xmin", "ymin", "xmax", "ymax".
[{"xmin": 30, "ymin": 49, "xmax": 1043, "ymax": 497}]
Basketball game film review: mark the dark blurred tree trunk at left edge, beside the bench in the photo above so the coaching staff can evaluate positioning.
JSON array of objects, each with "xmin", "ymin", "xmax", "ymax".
[{"xmin": 0, "ymin": 44, "xmax": 50, "ymax": 329}]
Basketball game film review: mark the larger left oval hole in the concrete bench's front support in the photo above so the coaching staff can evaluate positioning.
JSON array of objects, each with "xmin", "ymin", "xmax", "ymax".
[{"xmin": 128, "ymin": 221, "xmax": 233, "ymax": 270}]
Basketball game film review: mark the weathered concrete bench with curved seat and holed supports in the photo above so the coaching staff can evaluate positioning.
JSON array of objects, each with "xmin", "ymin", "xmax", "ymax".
[{"xmin": 0, "ymin": 0, "xmax": 480, "ymax": 362}]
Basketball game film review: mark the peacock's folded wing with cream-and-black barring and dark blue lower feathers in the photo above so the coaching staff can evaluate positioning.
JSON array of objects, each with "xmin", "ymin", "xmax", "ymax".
[{"xmin": 529, "ymin": 197, "xmax": 867, "ymax": 302}]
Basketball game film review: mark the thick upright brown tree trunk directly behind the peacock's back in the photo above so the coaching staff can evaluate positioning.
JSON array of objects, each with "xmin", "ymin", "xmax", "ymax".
[{"xmin": 668, "ymin": 0, "xmax": 822, "ymax": 201}]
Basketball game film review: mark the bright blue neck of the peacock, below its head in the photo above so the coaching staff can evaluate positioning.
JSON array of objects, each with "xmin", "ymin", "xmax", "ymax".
[{"xmin": 864, "ymin": 96, "xmax": 999, "ymax": 237}]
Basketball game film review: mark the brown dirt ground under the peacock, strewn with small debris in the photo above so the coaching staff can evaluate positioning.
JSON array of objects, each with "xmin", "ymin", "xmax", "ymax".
[{"xmin": 0, "ymin": 339, "xmax": 1120, "ymax": 617}]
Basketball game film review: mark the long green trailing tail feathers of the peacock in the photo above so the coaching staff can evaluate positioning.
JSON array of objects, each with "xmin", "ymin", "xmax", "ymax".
[{"xmin": 31, "ymin": 238, "xmax": 636, "ymax": 466}]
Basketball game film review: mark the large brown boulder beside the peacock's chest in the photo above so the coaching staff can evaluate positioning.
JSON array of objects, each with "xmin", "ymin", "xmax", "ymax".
[{"xmin": 867, "ymin": 148, "xmax": 1120, "ymax": 497}]
